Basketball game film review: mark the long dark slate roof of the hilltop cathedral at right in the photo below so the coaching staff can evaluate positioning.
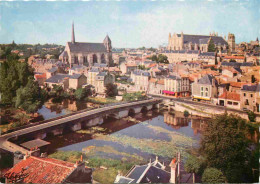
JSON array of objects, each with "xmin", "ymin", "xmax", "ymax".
[{"xmin": 177, "ymin": 34, "xmax": 228, "ymax": 45}]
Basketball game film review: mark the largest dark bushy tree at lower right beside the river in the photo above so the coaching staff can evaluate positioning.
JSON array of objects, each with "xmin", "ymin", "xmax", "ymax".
[{"xmin": 200, "ymin": 113, "xmax": 253, "ymax": 182}]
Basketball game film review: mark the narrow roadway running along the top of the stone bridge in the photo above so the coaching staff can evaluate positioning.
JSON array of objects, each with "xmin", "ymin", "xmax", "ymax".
[{"xmin": 0, "ymin": 99, "xmax": 160, "ymax": 151}]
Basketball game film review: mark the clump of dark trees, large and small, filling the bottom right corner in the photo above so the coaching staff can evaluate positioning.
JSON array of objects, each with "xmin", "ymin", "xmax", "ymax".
[{"xmin": 185, "ymin": 114, "xmax": 259, "ymax": 183}]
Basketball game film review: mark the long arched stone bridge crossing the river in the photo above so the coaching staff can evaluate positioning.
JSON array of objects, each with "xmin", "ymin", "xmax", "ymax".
[{"xmin": 0, "ymin": 99, "xmax": 162, "ymax": 153}]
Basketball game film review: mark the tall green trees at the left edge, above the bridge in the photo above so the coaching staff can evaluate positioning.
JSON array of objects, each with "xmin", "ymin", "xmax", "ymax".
[{"xmin": 0, "ymin": 49, "xmax": 46, "ymax": 113}]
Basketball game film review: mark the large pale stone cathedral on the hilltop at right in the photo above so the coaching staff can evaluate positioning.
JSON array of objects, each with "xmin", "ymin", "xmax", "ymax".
[{"xmin": 168, "ymin": 32, "xmax": 231, "ymax": 52}]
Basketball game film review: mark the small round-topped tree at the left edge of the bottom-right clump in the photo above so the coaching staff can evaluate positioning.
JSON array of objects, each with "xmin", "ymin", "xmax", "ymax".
[{"xmin": 184, "ymin": 156, "xmax": 202, "ymax": 183}]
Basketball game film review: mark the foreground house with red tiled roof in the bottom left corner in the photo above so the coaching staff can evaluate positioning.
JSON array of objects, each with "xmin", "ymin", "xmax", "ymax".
[{"xmin": 4, "ymin": 156, "xmax": 92, "ymax": 183}]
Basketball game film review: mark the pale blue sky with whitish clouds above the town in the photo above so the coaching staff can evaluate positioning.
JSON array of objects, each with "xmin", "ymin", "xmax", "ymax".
[{"xmin": 0, "ymin": 0, "xmax": 260, "ymax": 48}]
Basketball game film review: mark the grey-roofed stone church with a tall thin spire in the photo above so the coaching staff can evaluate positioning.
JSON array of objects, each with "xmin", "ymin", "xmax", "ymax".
[{"xmin": 59, "ymin": 23, "xmax": 113, "ymax": 67}]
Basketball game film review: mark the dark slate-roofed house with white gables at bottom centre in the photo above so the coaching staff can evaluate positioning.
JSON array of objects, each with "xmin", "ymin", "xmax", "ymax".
[{"xmin": 114, "ymin": 153, "xmax": 181, "ymax": 183}]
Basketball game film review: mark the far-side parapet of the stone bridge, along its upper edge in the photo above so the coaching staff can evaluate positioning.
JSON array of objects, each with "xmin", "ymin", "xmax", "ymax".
[{"xmin": 0, "ymin": 98, "xmax": 157, "ymax": 135}]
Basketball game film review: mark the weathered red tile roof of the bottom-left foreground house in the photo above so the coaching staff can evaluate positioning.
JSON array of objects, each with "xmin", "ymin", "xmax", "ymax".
[{"xmin": 5, "ymin": 156, "xmax": 75, "ymax": 183}]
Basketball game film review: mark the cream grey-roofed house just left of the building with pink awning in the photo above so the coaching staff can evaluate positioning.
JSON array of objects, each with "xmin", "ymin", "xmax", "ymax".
[{"xmin": 130, "ymin": 70, "xmax": 151, "ymax": 91}]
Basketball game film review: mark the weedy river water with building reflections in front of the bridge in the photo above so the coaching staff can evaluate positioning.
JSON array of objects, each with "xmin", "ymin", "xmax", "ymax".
[{"xmin": 43, "ymin": 111, "xmax": 206, "ymax": 161}]
